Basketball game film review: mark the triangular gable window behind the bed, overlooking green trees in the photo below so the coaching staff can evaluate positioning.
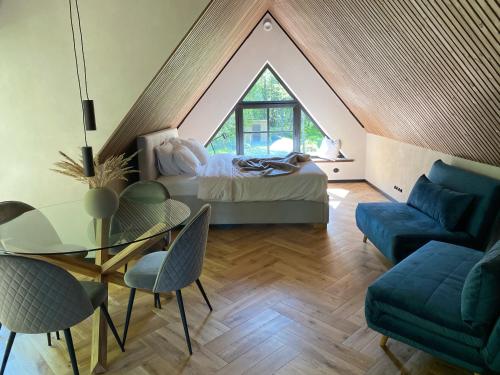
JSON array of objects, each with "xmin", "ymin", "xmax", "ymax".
[{"xmin": 207, "ymin": 65, "xmax": 325, "ymax": 156}]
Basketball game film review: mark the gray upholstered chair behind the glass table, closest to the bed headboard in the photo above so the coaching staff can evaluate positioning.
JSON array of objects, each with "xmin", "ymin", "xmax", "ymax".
[{"xmin": 109, "ymin": 181, "xmax": 171, "ymax": 309}]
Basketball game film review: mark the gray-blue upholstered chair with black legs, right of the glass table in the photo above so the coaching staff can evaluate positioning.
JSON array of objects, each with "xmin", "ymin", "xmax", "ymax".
[{"xmin": 122, "ymin": 204, "xmax": 212, "ymax": 354}]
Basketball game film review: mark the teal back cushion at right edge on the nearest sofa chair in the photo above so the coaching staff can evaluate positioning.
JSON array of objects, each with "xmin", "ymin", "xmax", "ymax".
[{"xmin": 461, "ymin": 241, "xmax": 500, "ymax": 332}]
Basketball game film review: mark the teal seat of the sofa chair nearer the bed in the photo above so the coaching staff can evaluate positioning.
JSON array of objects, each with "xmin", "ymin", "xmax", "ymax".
[{"xmin": 356, "ymin": 202, "xmax": 474, "ymax": 263}]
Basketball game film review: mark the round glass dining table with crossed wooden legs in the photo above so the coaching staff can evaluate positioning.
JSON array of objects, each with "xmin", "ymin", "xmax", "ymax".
[{"xmin": 0, "ymin": 199, "xmax": 191, "ymax": 373}]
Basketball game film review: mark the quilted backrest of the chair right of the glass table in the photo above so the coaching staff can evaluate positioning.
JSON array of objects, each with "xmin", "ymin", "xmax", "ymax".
[{"xmin": 153, "ymin": 204, "xmax": 210, "ymax": 292}]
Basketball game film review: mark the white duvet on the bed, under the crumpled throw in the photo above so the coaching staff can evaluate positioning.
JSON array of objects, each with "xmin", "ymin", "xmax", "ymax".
[{"xmin": 197, "ymin": 154, "xmax": 328, "ymax": 202}]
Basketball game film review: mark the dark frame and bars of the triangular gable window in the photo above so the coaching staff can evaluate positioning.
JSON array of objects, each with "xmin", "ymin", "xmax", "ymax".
[{"xmin": 205, "ymin": 64, "xmax": 328, "ymax": 155}]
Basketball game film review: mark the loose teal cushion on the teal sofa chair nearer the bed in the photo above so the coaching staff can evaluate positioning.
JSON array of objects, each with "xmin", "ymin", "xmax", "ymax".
[{"xmin": 408, "ymin": 175, "xmax": 474, "ymax": 231}]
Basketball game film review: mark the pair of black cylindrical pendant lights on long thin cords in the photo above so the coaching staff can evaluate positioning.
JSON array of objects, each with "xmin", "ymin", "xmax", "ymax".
[{"xmin": 68, "ymin": 0, "xmax": 97, "ymax": 177}]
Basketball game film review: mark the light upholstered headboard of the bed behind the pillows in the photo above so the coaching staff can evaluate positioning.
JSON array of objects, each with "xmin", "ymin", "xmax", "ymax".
[{"xmin": 137, "ymin": 128, "xmax": 179, "ymax": 180}]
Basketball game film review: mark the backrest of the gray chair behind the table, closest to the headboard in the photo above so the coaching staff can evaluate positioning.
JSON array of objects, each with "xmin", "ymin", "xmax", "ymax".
[{"xmin": 110, "ymin": 181, "xmax": 170, "ymax": 239}]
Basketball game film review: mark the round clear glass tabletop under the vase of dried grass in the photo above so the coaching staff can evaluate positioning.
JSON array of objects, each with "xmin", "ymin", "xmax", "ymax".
[{"xmin": 0, "ymin": 199, "xmax": 191, "ymax": 255}]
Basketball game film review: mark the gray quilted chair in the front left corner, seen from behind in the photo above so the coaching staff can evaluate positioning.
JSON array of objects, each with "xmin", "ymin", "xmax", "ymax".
[{"xmin": 0, "ymin": 255, "xmax": 125, "ymax": 375}]
